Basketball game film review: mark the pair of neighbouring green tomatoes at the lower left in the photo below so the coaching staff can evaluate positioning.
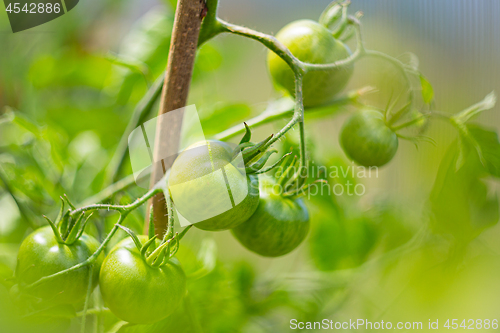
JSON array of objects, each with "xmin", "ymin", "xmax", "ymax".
[{"xmin": 13, "ymin": 226, "xmax": 186, "ymax": 324}]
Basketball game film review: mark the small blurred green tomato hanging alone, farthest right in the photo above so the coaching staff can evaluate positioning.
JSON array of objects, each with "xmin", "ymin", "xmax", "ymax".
[{"xmin": 340, "ymin": 109, "xmax": 398, "ymax": 167}]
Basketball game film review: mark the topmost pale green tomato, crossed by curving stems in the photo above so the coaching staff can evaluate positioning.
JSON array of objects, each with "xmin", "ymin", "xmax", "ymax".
[{"xmin": 267, "ymin": 20, "xmax": 354, "ymax": 107}]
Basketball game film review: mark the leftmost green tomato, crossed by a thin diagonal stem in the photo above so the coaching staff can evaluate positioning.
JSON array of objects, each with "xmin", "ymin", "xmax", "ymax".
[{"xmin": 16, "ymin": 226, "xmax": 104, "ymax": 304}]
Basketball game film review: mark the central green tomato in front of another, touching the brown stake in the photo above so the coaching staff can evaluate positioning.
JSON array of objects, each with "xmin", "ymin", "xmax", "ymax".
[{"xmin": 168, "ymin": 140, "xmax": 259, "ymax": 231}]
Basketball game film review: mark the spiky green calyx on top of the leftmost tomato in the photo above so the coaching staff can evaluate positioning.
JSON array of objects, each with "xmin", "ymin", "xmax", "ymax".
[{"xmin": 43, "ymin": 195, "xmax": 92, "ymax": 245}]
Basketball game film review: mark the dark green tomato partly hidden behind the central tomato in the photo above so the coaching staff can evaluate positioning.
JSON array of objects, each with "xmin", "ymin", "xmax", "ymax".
[{"xmin": 231, "ymin": 178, "xmax": 309, "ymax": 257}]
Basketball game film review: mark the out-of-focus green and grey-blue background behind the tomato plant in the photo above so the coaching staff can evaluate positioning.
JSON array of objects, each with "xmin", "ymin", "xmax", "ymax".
[{"xmin": 0, "ymin": 0, "xmax": 500, "ymax": 332}]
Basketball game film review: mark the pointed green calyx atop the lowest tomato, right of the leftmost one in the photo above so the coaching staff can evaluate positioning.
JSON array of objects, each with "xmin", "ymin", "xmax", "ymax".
[{"xmin": 117, "ymin": 224, "xmax": 190, "ymax": 268}]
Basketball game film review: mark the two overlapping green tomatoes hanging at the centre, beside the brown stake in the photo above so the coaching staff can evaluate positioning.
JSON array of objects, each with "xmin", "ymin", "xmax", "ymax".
[{"xmin": 169, "ymin": 140, "xmax": 309, "ymax": 257}]
